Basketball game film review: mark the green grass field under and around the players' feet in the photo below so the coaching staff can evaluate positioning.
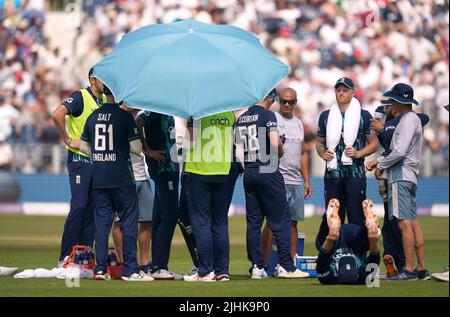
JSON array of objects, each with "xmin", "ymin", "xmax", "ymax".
[{"xmin": 0, "ymin": 215, "xmax": 449, "ymax": 297}]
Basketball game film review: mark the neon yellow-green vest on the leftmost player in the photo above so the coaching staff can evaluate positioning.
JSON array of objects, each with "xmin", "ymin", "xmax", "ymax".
[{"xmin": 66, "ymin": 89, "xmax": 106, "ymax": 156}]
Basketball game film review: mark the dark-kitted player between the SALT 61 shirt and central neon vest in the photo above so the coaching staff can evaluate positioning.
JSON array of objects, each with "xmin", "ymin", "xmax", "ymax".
[{"xmin": 136, "ymin": 111, "xmax": 181, "ymax": 280}]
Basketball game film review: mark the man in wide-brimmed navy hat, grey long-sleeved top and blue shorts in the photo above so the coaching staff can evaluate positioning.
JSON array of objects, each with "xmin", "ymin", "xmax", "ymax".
[{"xmin": 367, "ymin": 83, "xmax": 429, "ymax": 281}]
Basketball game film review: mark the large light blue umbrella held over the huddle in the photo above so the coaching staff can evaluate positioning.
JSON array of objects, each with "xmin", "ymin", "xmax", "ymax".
[{"xmin": 94, "ymin": 19, "xmax": 288, "ymax": 118}]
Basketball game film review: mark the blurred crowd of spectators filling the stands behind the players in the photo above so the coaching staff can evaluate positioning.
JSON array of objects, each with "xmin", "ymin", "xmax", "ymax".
[{"xmin": 0, "ymin": 0, "xmax": 449, "ymax": 176}]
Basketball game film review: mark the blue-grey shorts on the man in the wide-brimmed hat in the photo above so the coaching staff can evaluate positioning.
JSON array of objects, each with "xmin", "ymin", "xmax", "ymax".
[{"xmin": 388, "ymin": 181, "xmax": 417, "ymax": 220}]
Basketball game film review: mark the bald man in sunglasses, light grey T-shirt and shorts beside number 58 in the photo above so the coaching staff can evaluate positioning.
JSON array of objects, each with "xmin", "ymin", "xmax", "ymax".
[{"xmin": 262, "ymin": 87, "xmax": 312, "ymax": 265}]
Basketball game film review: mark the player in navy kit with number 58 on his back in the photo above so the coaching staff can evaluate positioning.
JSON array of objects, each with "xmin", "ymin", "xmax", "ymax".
[{"xmin": 236, "ymin": 89, "xmax": 308, "ymax": 279}]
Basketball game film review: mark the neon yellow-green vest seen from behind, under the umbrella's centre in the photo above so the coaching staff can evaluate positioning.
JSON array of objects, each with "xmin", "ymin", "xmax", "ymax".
[{"xmin": 185, "ymin": 111, "xmax": 234, "ymax": 175}]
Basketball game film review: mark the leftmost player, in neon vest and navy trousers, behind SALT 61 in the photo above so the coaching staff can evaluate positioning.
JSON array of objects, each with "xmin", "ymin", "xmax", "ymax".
[{"xmin": 53, "ymin": 68, "xmax": 105, "ymax": 265}]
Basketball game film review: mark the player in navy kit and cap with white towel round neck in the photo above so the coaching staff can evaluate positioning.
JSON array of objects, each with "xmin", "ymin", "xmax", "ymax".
[{"xmin": 316, "ymin": 77, "xmax": 378, "ymax": 249}]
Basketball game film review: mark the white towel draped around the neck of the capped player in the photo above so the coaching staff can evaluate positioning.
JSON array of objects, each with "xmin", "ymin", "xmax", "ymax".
[{"xmin": 326, "ymin": 98, "xmax": 361, "ymax": 171}]
